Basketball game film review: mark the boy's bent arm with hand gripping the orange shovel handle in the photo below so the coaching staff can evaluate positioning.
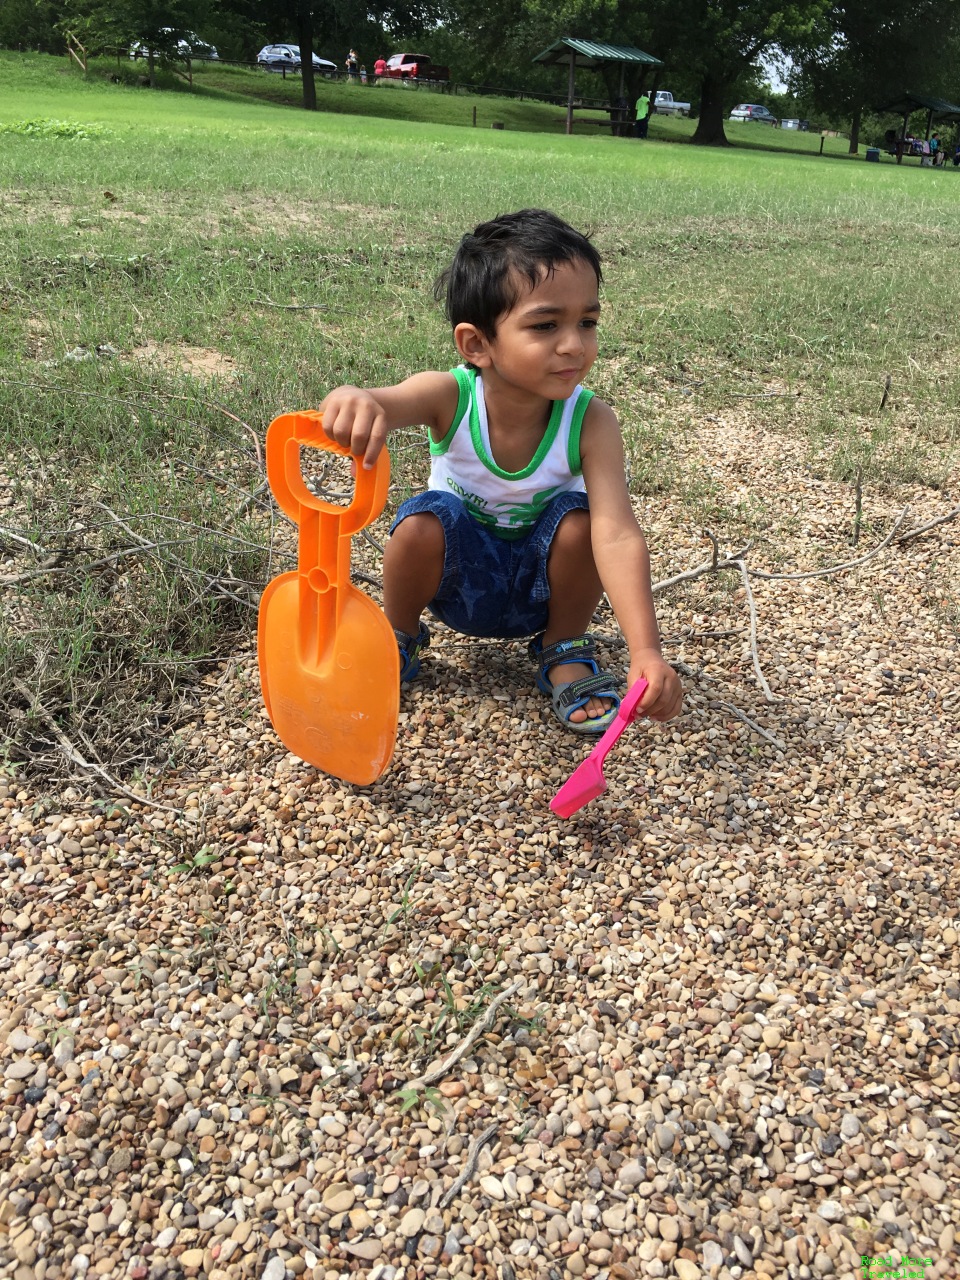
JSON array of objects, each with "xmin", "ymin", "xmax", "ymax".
[{"xmin": 320, "ymin": 372, "xmax": 460, "ymax": 468}]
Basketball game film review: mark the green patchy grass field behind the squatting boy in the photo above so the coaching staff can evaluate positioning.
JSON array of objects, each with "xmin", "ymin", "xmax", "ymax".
[{"xmin": 0, "ymin": 54, "xmax": 960, "ymax": 771}]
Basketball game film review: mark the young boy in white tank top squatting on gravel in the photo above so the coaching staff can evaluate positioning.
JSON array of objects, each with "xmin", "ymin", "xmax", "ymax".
[{"xmin": 320, "ymin": 209, "xmax": 682, "ymax": 733}]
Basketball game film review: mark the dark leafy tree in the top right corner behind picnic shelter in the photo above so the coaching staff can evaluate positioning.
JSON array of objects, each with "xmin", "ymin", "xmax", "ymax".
[{"xmin": 792, "ymin": 0, "xmax": 956, "ymax": 155}]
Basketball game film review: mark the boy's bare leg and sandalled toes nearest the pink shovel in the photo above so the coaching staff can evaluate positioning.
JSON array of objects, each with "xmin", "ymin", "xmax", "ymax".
[{"xmin": 543, "ymin": 509, "xmax": 613, "ymax": 724}]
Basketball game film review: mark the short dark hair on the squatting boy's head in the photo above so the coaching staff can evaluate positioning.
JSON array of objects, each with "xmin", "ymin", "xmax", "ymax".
[{"xmin": 434, "ymin": 209, "xmax": 603, "ymax": 338}]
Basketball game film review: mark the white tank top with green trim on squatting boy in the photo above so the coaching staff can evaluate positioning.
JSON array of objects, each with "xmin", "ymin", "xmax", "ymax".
[{"xmin": 428, "ymin": 369, "xmax": 594, "ymax": 539}]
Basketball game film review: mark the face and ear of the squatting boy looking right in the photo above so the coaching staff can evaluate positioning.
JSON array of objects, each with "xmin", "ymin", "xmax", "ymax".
[{"xmin": 454, "ymin": 260, "xmax": 600, "ymax": 401}]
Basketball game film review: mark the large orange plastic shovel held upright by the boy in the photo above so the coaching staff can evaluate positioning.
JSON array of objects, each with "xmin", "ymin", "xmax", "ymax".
[{"xmin": 257, "ymin": 412, "xmax": 399, "ymax": 786}]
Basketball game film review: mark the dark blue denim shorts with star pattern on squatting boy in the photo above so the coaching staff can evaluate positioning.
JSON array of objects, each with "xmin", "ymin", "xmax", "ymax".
[{"xmin": 390, "ymin": 489, "xmax": 589, "ymax": 640}]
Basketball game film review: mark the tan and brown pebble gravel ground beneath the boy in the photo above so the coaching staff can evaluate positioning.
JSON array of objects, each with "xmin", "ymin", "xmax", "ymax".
[{"xmin": 0, "ymin": 419, "xmax": 960, "ymax": 1280}]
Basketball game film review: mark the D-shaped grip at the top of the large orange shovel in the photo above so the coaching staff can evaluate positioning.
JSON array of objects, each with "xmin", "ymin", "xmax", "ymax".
[{"xmin": 266, "ymin": 410, "xmax": 390, "ymax": 536}]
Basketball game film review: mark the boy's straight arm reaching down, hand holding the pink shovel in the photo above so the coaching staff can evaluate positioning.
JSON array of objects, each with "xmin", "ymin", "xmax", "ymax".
[{"xmin": 580, "ymin": 399, "xmax": 684, "ymax": 721}]
